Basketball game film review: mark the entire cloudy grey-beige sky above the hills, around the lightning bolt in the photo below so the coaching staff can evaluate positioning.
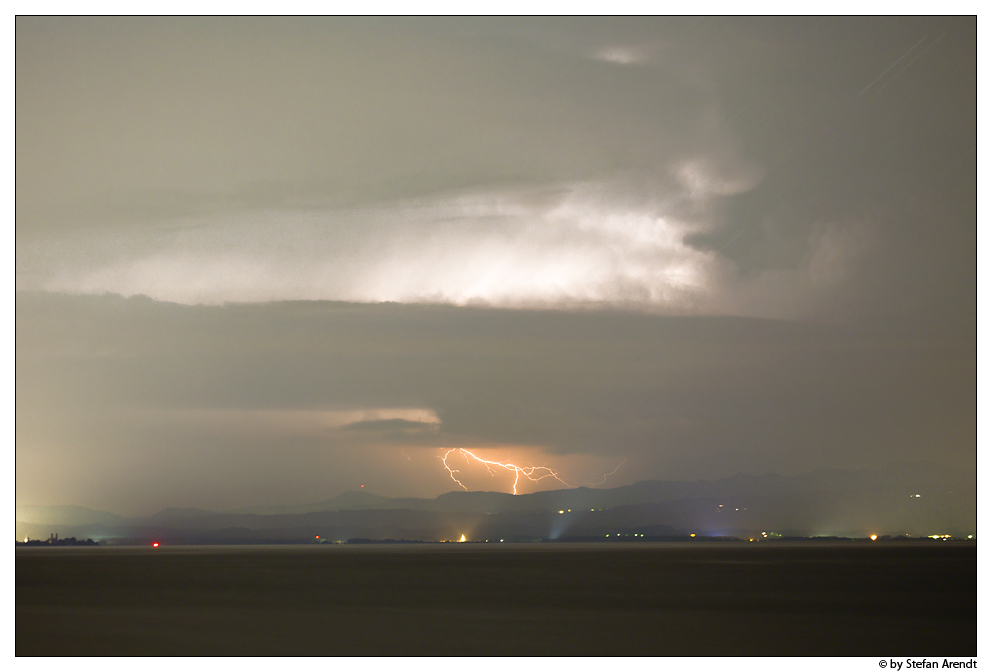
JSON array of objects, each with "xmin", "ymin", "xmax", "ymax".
[{"xmin": 15, "ymin": 17, "xmax": 978, "ymax": 515}]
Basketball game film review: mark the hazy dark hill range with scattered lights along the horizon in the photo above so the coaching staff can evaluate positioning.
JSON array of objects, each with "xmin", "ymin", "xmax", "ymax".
[{"xmin": 17, "ymin": 463, "xmax": 977, "ymax": 543}]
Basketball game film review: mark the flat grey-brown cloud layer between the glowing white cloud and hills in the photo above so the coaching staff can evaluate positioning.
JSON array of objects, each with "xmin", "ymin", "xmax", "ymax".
[{"xmin": 17, "ymin": 295, "xmax": 976, "ymax": 506}]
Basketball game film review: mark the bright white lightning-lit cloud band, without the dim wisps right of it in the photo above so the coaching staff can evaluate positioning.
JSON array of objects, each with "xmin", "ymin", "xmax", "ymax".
[{"xmin": 19, "ymin": 180, "xmax": 743, "ymax": 311}]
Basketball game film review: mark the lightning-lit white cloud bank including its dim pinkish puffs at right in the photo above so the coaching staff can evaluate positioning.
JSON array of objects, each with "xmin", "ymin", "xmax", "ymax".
[{"xmin": 17, "ymin": 168, "xmax": 880, "ymax": 326}]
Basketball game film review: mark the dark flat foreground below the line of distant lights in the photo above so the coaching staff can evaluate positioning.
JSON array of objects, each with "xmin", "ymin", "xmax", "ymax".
[{"xmin": 15, "ymin": 542, "xmax": 978, "ymax": 657}]
